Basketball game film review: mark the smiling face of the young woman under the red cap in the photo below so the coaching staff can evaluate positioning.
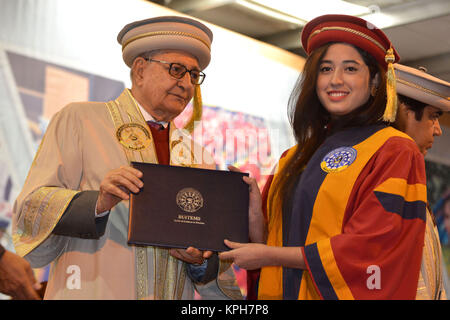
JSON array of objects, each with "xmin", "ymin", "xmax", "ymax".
[{"xmin": 316, "ymin": 43, "xmax": 371, "ymax": 116}]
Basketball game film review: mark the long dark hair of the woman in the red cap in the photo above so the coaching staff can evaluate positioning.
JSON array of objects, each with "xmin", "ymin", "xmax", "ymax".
[{"xmin": 269, "ymin": 43, "xmax": 386, "ymax": 216}]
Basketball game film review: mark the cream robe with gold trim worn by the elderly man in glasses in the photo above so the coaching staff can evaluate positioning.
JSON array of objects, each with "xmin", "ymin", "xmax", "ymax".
[{"xmin": 13, "ymin": 89, "xmax": 240, "ymax": 299}]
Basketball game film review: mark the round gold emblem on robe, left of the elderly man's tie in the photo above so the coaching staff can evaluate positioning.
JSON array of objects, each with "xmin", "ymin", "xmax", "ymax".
[{"xmin": 116, "ymin": 123, "xmax": 151, "ymax": 150}]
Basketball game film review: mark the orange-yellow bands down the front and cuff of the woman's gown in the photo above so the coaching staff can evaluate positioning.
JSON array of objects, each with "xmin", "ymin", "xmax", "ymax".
[{"xmin": 258, "ymin": 127, "xmax": 410, "ymax": 299}]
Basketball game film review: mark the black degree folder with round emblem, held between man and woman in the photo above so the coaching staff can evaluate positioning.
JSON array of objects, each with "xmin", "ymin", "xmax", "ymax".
[{"xmin": 128, "ymin": 162, "xmax": 249, "ymax": 251}]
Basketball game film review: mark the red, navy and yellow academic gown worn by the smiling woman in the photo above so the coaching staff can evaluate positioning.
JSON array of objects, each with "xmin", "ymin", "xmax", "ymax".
[{"xmin": 258, "ymin": 126, "xmax": 426, "ymax": 299}]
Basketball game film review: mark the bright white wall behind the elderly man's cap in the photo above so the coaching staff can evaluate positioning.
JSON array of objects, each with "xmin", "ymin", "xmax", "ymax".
[{"xmin": 0, "ymin": 0, "xmax": 304, "ymax": 172}]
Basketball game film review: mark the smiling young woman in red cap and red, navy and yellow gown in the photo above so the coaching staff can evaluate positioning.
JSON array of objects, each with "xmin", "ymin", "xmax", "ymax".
[{"xmin": 220, "ymin": 15, "xmax": 426, "ymax": 299}]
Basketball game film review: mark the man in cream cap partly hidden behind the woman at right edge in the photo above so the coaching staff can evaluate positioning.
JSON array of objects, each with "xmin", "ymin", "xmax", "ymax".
[{"xmin": 394, "ymin": 64, "xmax": 450, "ymax": 300}]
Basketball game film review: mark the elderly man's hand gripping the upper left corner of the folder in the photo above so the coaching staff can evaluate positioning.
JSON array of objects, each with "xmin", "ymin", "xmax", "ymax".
[{"xmin": 96, "ymin": 166, "xmax": 144, "ymax": 213}]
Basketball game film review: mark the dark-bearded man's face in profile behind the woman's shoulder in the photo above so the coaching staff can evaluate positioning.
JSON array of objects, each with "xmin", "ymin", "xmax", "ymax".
[{"xmin": 399, "ymin": 105, "xmax": 442, "ymax": 156}]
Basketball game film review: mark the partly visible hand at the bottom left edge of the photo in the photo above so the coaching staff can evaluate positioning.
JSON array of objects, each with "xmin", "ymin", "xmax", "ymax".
[{"xmin": 0, "ymin": 251, "xmax": 40, "ymax": 300}]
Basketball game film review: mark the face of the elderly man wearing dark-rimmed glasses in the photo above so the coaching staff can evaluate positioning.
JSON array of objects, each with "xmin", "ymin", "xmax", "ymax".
[{"xmin": 134, "ymin": 51, "xmax": 200, "ymax": 121}]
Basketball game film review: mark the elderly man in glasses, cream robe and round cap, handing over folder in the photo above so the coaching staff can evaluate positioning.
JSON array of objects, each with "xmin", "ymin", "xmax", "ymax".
[{"xmin": 13, "ymin": 17, "xmax": 240, "ymax": 299}]
